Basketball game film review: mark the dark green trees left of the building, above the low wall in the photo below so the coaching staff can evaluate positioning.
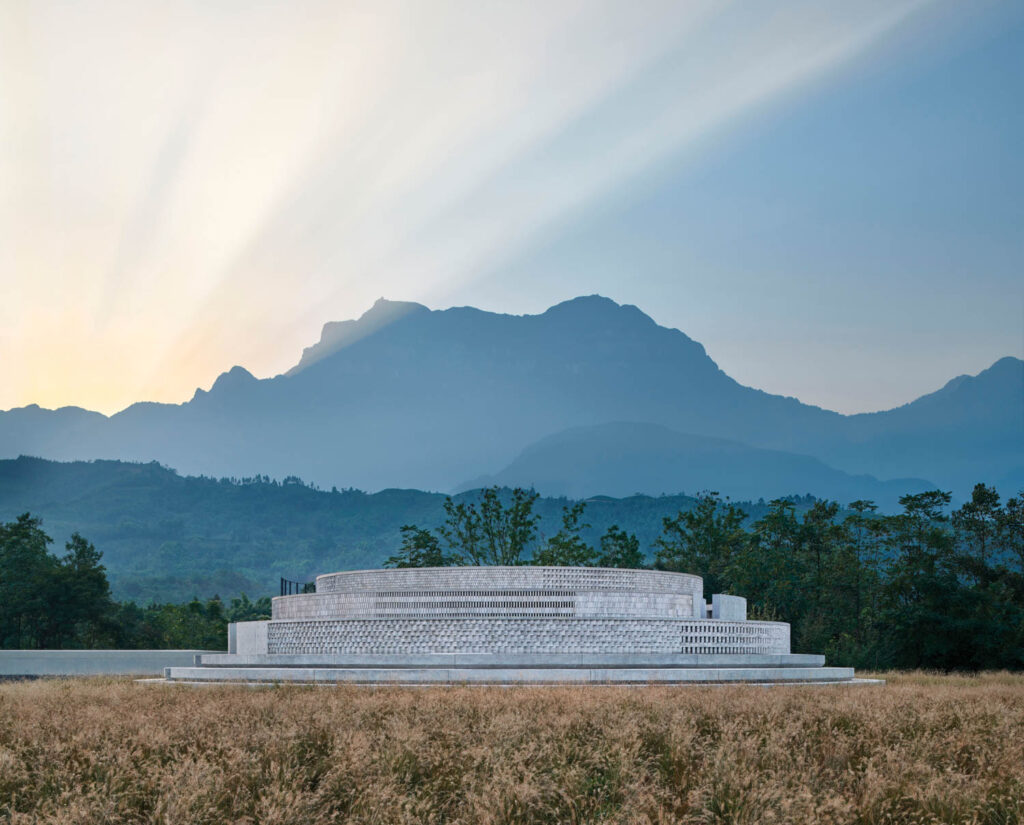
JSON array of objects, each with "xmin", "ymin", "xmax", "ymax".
[{"xmin": 0, "ymin": 513, "xmax": 270, "ymax": 650}]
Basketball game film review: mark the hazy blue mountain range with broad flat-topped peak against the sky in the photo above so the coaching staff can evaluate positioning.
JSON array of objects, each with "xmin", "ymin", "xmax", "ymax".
[{"xmin": 0, "ymin": 296, "xmax": 1024, "ymax": 497}]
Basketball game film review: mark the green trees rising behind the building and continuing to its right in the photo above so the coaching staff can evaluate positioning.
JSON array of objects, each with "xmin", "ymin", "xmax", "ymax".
[{"xmin": 386, "ymin": 484, "xmax": 1024, "ymax": 669}]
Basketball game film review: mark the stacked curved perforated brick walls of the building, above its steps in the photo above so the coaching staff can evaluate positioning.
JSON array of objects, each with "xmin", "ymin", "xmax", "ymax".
[{"xmin": 266, "ymin": 566, "xmax": 790, "ymax": 656}]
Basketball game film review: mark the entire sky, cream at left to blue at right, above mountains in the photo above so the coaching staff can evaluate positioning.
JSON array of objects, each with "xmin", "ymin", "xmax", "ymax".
[{"xmin": 0, "ymin": 0, "xmax": 1024, "ymax": 414}]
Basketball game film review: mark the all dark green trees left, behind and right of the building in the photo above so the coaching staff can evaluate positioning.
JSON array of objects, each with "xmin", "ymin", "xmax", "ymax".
[{"xmin": 0, "ymin": 484, "xmax": 1024, "ymax": 669}]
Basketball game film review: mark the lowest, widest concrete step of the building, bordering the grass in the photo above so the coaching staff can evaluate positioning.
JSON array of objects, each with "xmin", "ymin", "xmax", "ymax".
[{"xmin": 164, "ymin": 666, "xmax": 853, "ymax": 685}]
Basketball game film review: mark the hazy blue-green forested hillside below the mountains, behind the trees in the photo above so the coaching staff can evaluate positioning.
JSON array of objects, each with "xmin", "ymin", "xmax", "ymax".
[{"xmin": 0, "ymin": 457, "xmax": 790, "ymax": 602}]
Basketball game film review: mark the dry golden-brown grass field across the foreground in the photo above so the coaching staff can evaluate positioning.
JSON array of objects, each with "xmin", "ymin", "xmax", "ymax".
[{"xmin": 0, "ymin": 674, "xmax": 1024, "ymax": 825}]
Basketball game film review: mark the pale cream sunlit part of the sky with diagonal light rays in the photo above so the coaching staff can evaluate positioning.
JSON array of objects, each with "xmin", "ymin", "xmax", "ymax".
[{"xmin": 0, "ymin": 0, "xmax": 942, "ymax": 413}]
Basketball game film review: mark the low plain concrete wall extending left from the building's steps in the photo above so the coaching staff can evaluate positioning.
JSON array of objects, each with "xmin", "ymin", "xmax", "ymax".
[{"xmin": 0, "ymin": 650, "xmax": 217, "ymax": 678}]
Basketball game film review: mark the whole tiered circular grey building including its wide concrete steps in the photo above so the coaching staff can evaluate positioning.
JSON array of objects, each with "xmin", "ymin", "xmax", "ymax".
[{"xmin": 166, "ymin": 566, "xmax": 853, "ymax": 684}]
